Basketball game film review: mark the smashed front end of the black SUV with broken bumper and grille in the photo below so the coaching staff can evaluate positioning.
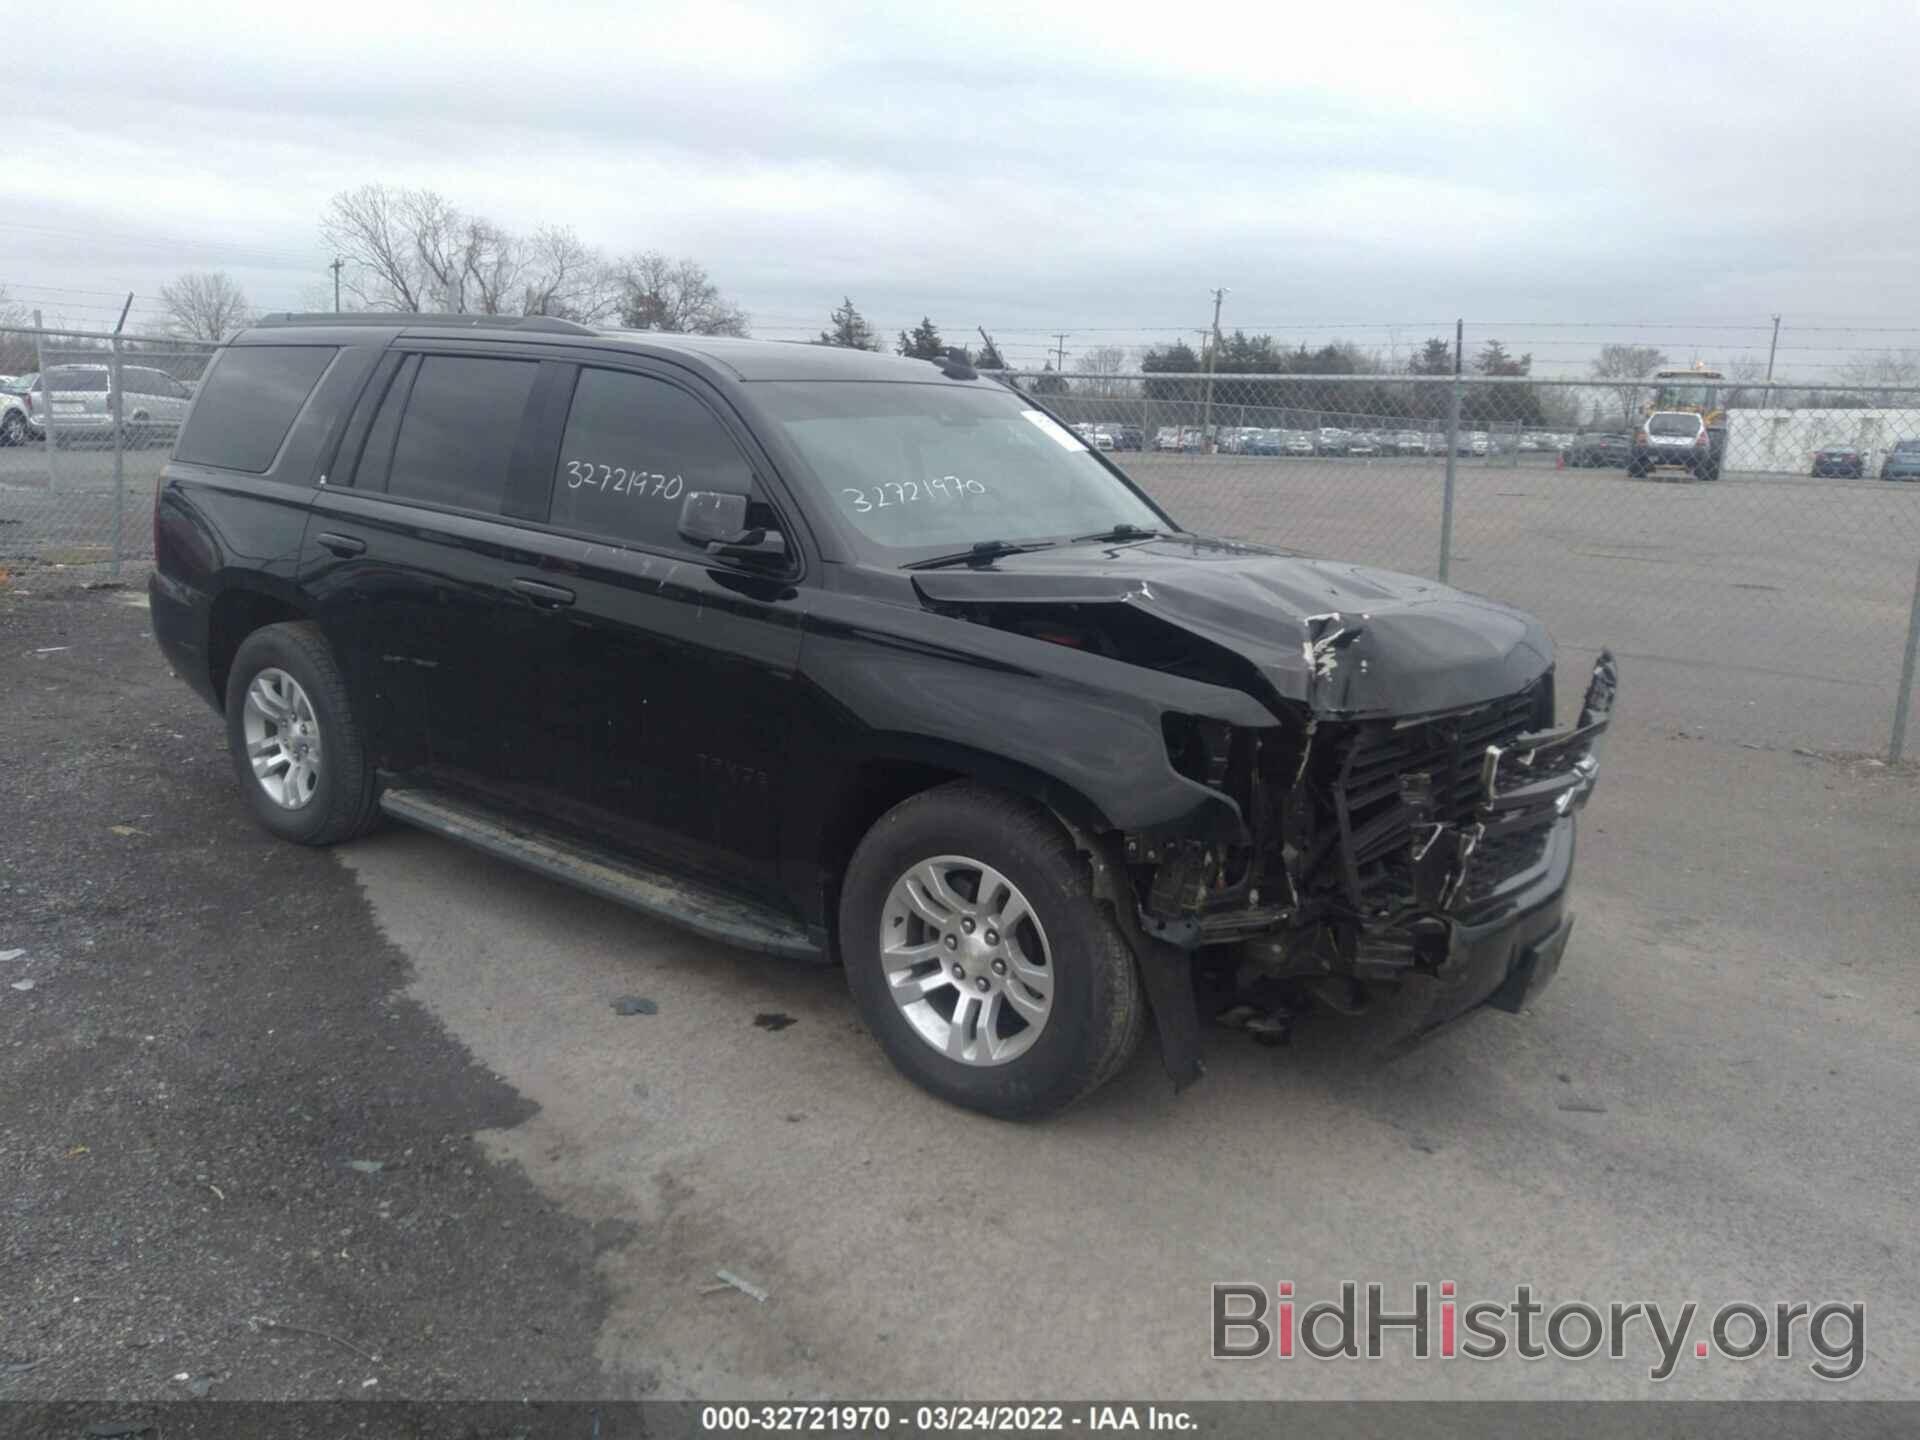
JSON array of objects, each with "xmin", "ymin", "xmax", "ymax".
[{"xmin": 1121, "ymin": 648, "xmax": 1619, "ymax": 1037}]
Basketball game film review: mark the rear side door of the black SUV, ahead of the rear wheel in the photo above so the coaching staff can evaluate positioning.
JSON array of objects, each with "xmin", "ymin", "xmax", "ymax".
[{"xmin": 301, "ymin": 342, "xmax": 564, "ymax": 799}]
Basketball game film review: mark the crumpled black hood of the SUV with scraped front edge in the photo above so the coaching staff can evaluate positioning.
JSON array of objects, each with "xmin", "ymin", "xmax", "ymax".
[{"xmin": 914, "ymin": 536, "xmax": 1553, "ymax": 714}]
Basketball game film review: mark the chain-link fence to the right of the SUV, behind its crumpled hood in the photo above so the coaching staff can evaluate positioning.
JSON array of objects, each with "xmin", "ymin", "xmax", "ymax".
[{"xmin": 1010, "ymin": 371, "xmax": 1920, "ymax": 758}]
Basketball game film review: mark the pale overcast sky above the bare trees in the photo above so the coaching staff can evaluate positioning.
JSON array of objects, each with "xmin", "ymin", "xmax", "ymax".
[{"xmin": 0, "ymin": 0, "xmax": 1920, "ymax": 380}]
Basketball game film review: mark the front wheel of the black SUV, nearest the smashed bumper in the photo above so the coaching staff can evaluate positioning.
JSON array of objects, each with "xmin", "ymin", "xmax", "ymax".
[{"xmin": 839, "ymin": 781, "xmax": 1146, "ymax": 1119}]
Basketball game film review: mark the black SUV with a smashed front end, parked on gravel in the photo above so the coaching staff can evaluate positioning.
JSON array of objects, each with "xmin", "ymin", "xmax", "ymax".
[{"xmin": 152, "ymin": 315, "xmax": 1615, "ymax": 1116}]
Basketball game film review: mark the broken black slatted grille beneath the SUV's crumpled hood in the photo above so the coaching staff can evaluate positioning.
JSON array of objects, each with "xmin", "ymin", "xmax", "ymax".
[{"xmin": 1331, "ymin": 682, "xmax": 1546, "ymax": 914}]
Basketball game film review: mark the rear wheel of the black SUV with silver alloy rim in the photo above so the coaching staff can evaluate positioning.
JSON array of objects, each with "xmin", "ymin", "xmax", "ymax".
[{"xmin": 227, "ymin": 620, "xmax": 378, "ymax": 845}]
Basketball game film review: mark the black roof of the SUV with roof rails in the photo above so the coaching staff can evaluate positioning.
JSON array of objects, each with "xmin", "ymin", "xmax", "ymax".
[{"xmin": 234, "ymin": 313, "xmax": 975, "ymax": 384}]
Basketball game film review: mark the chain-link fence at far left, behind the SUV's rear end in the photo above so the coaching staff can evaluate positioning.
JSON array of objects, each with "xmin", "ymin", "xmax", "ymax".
[{"xmin": 0, "ymin": 328, "xmax": 213, "ymax": 588}]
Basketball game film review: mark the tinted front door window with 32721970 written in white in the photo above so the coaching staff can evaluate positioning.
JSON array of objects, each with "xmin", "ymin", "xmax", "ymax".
[{"xmin": 551, "ymin": 369, "xmax": 758, "ymax": 553}]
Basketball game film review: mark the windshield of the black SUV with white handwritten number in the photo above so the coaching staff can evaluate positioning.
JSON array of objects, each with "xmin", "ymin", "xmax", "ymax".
[{"xmin": 755, "ymin": 380, "xmax": 1167, "ymax": 549}]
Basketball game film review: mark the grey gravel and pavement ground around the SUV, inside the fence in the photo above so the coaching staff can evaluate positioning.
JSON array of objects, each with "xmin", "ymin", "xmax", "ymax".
[{"xmin": 0, "ymin": 568, "xmax": 1920, "ymax": 1398}]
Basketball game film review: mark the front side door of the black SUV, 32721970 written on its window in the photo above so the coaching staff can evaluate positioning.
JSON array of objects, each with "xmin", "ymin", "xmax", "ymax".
[{"xmin": 506, "ymin": 363, "xmax": 804, "ymax": 897}]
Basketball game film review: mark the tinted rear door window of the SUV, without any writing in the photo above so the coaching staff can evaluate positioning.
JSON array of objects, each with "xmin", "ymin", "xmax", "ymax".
[{"xmin": 382, "ymin": 355, "xmax": 540, "ymax": 515}]
